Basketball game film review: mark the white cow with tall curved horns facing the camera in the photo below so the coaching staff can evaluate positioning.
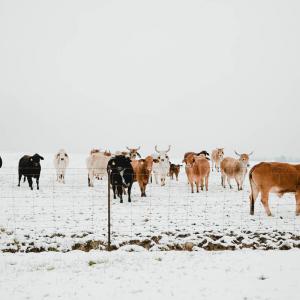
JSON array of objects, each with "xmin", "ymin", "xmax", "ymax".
[{"xmin": 152, "ymin": 146, "xmax": 171, "ymax": 186}]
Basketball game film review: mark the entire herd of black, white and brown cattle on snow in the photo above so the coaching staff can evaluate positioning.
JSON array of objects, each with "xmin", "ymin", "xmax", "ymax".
[{"xmin": 0, "ymin": 146, "xmax": 300, "ymax": 216}]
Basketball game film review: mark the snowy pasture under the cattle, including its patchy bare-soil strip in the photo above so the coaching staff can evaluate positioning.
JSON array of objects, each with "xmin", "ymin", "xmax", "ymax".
[{"xmin": 0, "ymin": 153, "xmax": 300, "ymax": 252}]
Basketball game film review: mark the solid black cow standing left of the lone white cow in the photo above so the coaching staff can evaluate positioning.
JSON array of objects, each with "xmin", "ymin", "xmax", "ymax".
[{"xmin": 18, "ymin": 154, "xmax": 44, "ymax": 190}]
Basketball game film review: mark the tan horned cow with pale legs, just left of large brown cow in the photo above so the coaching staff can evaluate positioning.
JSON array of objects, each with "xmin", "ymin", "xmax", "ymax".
[{"xmin": 221, "ymin": 151, "xmax": 253, "ymax": 191}]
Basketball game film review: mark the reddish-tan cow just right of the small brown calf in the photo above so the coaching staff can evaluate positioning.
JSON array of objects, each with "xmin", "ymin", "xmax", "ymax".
[{"xmin": 185, "ymin": 154, "xmax": 210, "ymax": 193}]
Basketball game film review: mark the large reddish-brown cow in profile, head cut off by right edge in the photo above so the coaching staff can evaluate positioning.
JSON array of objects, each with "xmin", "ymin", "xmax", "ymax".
[{"xmin": 249, "ymin": 162, "xmax": 300, "ymax": 216}]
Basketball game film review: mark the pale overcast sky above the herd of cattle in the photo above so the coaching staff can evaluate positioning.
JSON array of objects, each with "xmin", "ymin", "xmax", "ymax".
[{"xmin": 0, "ymin": 0, "xmax": 300, "ymax": 157}]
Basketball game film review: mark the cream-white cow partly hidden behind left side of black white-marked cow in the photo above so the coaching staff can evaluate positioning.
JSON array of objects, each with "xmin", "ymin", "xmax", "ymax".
[{"xmin": 86, "ymin": 149, "xmax": 112, "ymax": 187}]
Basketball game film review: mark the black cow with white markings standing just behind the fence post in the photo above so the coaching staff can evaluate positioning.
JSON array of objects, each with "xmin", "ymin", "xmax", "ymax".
[{"xmin": 107, "ymin": 155, "xmax": 134, "ymax": 203}]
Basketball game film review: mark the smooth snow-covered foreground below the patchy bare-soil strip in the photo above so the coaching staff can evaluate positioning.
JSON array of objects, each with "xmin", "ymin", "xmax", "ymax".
[{"xmin": 0, "ymin": 251, "xmax": 300, "ymax": 300}]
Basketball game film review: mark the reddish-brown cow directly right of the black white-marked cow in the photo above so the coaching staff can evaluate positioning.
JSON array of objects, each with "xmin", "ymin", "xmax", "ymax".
[{"xmin": 131, "ymin": 156, "xmax": 158, "ymax": 197}]
